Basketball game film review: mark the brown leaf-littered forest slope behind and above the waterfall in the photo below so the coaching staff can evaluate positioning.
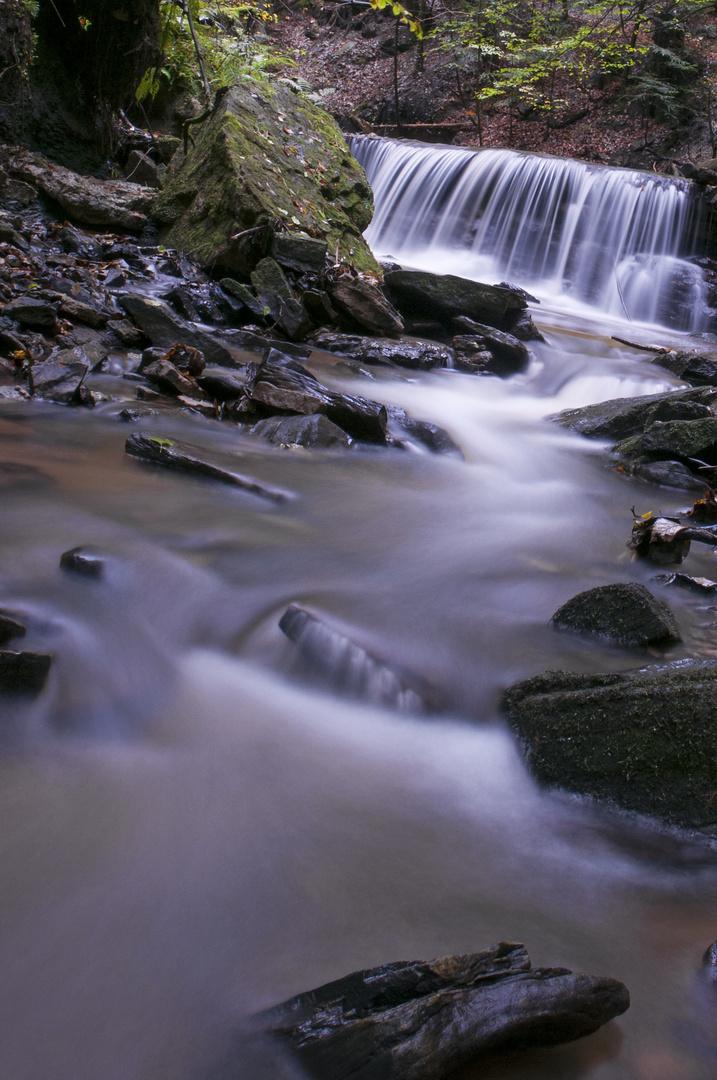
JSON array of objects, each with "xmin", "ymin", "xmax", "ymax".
[{"xmin": 275, "ymin": 4, "xmax": 717, "ymax": 173}]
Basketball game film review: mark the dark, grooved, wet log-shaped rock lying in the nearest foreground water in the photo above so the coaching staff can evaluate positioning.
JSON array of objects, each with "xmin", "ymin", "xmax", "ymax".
[{"xmin": 256, "ymin": 942, "xmax": 630, "ymax": 1080}]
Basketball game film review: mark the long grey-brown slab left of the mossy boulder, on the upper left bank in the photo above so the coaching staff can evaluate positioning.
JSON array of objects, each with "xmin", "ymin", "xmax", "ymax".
[{"xmin": 9, "ymin": 150, "xmax": 153, "ymax": 232}]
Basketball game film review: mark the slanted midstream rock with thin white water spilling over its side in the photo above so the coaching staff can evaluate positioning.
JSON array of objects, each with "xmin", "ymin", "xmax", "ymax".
[{"xmin": 279, "ymin": 604, "xmax": 441, "ymax": 713}]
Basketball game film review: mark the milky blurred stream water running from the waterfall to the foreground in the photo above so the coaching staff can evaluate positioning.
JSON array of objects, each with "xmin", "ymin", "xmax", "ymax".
[{"xmin": 0, "ymin": 143, "xmax": 717, "ymax": 1080}]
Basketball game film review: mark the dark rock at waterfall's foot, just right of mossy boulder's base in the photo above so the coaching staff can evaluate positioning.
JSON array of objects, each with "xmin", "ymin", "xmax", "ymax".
[{"xmin": 384, "ymin": 270, "xmax": 527, "ymax": 326}]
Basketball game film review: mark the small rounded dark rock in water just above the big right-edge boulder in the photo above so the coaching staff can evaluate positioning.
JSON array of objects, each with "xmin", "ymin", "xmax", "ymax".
[{"xmin": 551, "ymin": 582, "xmax": 681, "ymax": 646}]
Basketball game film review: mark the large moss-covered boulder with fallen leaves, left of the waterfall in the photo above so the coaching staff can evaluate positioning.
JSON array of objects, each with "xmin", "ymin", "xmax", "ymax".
[{"xmin": 153, "ymin": 78, "xmax": 379, "ymax": 275}]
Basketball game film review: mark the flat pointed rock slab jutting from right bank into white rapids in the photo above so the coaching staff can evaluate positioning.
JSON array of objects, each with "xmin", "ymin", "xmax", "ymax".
[{"xmin": 551, "ymin": 389, "xmax": 717, "ymax": 440}]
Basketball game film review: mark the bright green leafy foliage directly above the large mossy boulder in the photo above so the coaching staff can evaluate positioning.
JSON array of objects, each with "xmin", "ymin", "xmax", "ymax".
[{"xmin": 136, "ymin": 0, "xmax": 290, "ymax": 100}]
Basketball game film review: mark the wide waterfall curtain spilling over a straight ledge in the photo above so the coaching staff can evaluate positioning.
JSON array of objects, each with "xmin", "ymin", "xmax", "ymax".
[{"xmin": 351, "ymin": 136, "xmax": 713, "ymax": 333}]
